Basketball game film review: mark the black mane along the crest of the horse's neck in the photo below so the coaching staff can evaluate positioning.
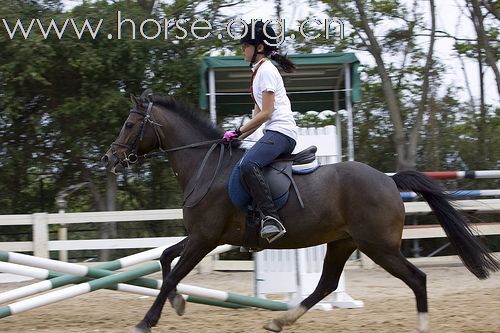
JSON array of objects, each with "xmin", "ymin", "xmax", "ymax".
[{"xmin": 153, "ymin": 95, "xmax": 224, "ymax": 140}]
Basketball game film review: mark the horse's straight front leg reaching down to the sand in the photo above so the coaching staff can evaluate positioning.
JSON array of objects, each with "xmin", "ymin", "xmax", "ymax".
[{"xmin": 134, "ymin": 236, "xmax": 217, "ymax": 333}]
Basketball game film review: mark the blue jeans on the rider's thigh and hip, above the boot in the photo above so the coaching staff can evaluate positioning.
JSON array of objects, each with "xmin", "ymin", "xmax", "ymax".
[{"xmin": 240, "ymin": 131, "xmax": 296, "ymax": 175}]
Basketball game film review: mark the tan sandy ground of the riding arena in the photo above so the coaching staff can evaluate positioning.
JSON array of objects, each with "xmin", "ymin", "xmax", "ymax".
[{"xmin": 0, "ymin": 267, "xmax": 500, "ymax": 333}]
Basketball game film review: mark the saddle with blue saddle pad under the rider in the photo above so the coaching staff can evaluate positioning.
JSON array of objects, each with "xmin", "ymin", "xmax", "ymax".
[{"xmin": 228, "ymin": 146, "xmax": 319, "ymax": 211}]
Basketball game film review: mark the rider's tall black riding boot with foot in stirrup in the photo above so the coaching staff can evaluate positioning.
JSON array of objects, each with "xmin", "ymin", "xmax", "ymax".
[{"xmin": 243, "ymin": 167, "xmax": 286, "ymax": 243}]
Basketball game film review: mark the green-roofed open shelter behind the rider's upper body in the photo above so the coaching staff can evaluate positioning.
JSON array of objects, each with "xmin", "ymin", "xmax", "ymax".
[{"xmin": 199, "ymin": 53, "xmax": 361, "ymax": 119}]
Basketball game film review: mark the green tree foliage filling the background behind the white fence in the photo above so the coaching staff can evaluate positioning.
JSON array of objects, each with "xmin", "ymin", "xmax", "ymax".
[{"xmin": 0, "ymin": 0, "xmax": 500, "ymax": 256}]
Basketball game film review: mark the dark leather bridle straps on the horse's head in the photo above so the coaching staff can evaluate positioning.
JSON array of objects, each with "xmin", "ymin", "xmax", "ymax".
[{"xmin": 111, "ymin": 96, "xmax": 165, "ymax": 168}]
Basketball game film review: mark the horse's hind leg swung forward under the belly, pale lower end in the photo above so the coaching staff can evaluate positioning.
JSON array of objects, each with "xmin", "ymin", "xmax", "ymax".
[{"xmin": 264, "ymin": 238, "xmax": 356, "ymax": 332}]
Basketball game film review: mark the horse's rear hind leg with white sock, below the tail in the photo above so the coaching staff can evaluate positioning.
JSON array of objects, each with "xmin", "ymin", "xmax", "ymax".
[{"xmin": 359, "ymin": 244, "xmax": 429, "ymax": 332}]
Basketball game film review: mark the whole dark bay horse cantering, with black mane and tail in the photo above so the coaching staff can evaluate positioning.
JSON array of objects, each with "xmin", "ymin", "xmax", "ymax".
[{"xmin": 102, "ymin": 92, "xmax": 500, "ymax": 332}]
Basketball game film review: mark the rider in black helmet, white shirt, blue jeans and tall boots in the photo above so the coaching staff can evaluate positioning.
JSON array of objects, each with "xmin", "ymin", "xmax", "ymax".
[{"xmin": 224, "ymin": 21, "xmax": 297, "ymax": 243}]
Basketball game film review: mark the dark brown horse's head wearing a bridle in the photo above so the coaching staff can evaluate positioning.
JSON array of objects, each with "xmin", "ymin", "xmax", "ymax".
[{"xmin": 101, "ymin": 89, "xmax": 161, "ymax": 173}]
